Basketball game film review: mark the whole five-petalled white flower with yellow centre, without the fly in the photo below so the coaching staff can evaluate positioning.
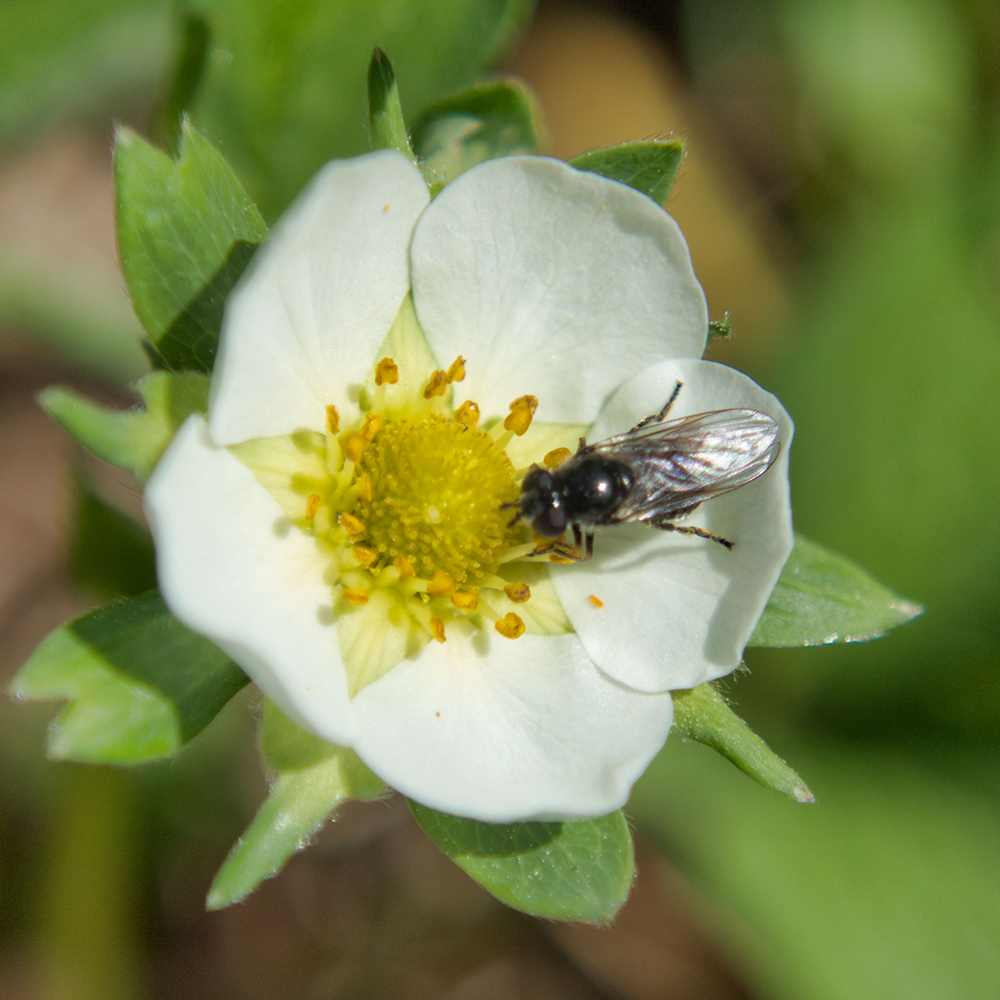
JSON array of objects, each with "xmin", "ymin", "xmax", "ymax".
[{"xmin": 146, "ymin": 152, "xmax": 792, "ymax": 822}]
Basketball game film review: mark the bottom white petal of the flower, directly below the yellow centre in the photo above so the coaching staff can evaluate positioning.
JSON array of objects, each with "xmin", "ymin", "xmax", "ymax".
[{"xmin": 354, "ymin": 625, "xmax": 673, "ymax": 823}]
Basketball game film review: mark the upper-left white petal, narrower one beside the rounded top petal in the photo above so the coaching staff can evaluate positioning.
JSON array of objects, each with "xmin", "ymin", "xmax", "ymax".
[{"xmin": 209, "ymin": 151, "xmax": 428, "ymax": 444}]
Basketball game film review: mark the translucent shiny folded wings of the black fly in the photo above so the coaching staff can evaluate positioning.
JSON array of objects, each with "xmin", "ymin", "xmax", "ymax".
[{"xmin": 588, "ymin": 410, "xmax": 781, "ymax": 523}]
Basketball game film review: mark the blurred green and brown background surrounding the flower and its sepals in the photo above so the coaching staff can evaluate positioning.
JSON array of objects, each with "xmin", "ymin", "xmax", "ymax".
[{"xmin": 0, "ymin": 0, "xmax": 1000, "ymax": 1000}]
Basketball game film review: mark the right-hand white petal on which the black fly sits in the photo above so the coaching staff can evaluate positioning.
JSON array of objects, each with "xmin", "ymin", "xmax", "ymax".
[{"xmin": 552, "ymin": 360, "xmax": 792, "ymax": 691}]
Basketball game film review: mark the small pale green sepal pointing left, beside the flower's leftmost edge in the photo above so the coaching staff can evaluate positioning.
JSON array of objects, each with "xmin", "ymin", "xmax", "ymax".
[{"xmin": 38, "ymin": 372, "xmax": 209, "ymax": 482}]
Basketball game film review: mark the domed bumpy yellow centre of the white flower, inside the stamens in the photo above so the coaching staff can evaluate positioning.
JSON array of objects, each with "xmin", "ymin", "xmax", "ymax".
[{"xmin": 356, "ymin": 414, "xmax": 519, "ymax": 584}]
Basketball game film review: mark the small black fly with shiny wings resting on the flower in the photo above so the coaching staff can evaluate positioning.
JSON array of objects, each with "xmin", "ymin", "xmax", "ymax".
[{"xmin": 512, "ymin": 382, "xmax": 781, "ymax": 561}]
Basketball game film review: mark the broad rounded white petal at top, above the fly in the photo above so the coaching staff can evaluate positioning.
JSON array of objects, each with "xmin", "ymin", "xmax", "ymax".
[{"xmin": 411, "ymin": 157, "xmax": 708, "ymax": 423}]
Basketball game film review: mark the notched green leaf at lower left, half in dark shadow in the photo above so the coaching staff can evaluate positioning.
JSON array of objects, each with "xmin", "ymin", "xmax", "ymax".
[{"xmin": 11, "ymin": 591, "xmax": 247, "ymax": 764}]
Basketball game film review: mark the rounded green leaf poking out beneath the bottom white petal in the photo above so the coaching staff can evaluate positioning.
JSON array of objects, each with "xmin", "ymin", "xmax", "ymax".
[{"xmin": 410, "ymin": 802, "xmax": 635, "ymax": 924}]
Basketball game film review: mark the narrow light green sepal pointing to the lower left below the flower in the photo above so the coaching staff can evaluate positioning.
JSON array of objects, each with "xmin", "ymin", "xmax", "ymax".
[{"xmin": 207, "ymin": 701, "xmax": 386, "ymax": 910}]
